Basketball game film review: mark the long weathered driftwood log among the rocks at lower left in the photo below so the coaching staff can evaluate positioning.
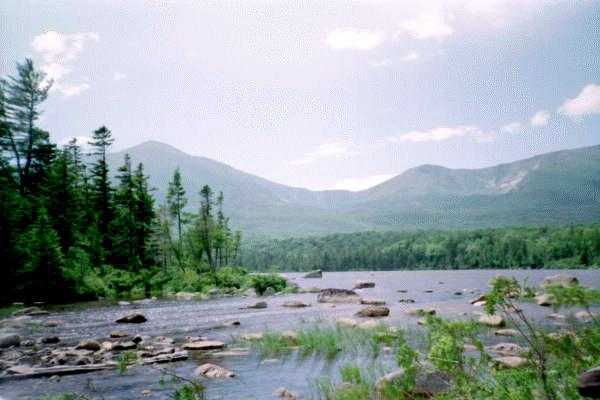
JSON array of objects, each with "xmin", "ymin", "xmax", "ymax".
[{"xmin": 0, "ymin": 351, "xmax": 188, "ymax": 382}]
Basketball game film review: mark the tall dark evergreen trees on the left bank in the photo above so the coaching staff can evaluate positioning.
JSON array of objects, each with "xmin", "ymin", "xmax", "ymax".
[{"xmin": 0, "ymin": 59, "xmax": 241, "ymax": 303}]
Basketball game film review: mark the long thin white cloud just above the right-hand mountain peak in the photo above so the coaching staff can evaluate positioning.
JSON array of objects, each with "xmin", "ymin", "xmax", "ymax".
[{"xmin": 388, "ymin": 125, "xmax": 495, "ymax": 143}]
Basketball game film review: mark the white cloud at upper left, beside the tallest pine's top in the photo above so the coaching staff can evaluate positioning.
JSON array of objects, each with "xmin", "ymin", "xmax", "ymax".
[{"xmin": 31, "ymin": 31, "xmax": 100, "ymax": 97}]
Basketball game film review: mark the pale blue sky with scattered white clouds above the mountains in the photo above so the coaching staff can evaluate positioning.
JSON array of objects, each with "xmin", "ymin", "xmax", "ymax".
[{"xmin": 0, "ymin": 0, "xmax": 600, "ymax": 190}]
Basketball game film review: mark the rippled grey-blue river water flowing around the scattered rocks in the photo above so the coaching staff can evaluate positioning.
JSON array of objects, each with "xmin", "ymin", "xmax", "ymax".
[{"xmin": 0, "ymin": 270, "xmax": 600, "ymax": 400}]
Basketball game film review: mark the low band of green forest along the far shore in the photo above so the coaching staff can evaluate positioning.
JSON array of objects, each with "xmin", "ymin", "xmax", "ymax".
[{"xmin": 242, "ymin": 224, "xmax": 600, "ymax": 271}]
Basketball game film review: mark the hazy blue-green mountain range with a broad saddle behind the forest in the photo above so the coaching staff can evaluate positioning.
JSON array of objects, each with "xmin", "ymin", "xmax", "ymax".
[{"xmin": 109, "ymin": 141, "xmax": 600, "ymax": 236}]
